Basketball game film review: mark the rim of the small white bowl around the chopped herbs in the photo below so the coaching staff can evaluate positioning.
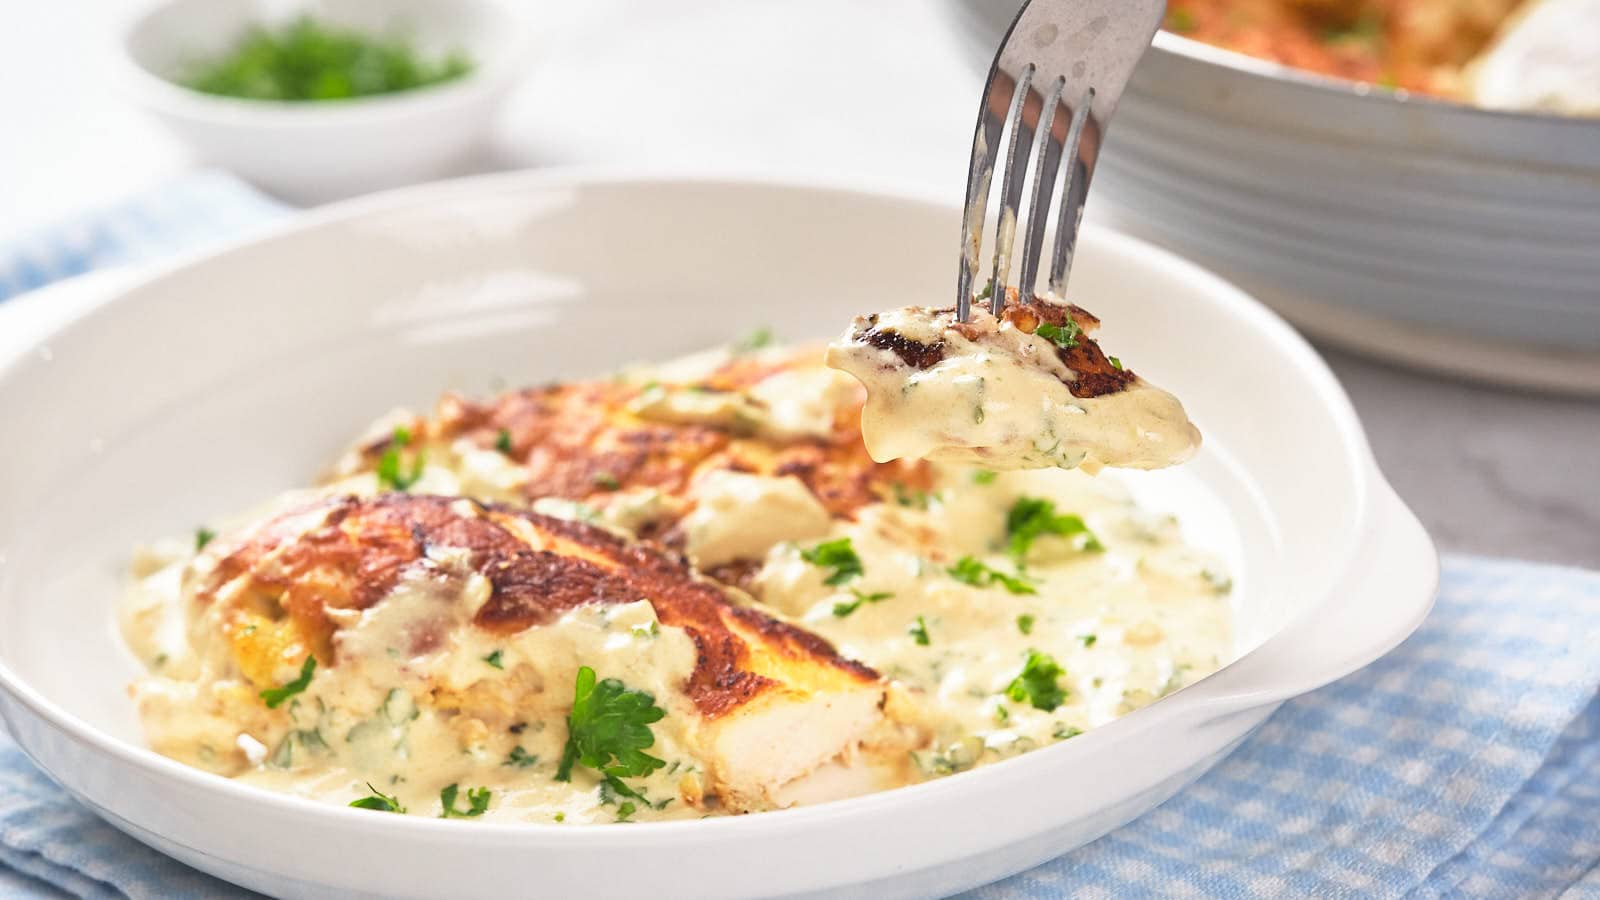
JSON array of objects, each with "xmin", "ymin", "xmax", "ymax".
[{"xmin": 107, "ymin": 0, "xmax": 531, "ymax": 130}]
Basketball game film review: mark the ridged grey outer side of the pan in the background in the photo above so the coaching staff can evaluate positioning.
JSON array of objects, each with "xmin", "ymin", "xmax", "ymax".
[{"xmin": 950, "ymin": 0, "xmax": 1600, "ymax": 392}]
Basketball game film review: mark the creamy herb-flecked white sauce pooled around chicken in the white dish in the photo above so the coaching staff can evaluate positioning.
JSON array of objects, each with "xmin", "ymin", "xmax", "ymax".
[{"xmin": 120, "ymin": 342, "xmax": 1234, "ymax": 823}]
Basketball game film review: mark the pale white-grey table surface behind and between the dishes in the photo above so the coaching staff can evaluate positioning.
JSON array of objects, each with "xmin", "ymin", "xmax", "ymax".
[{"xmin": 0, "ymin": 0, "xmax": 1600, "ymax": 567}]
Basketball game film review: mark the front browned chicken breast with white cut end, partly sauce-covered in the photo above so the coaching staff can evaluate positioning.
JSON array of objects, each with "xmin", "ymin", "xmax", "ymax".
[{"xmin": 144, "ymin": 493, "xmax": 906, "ymax": 812}]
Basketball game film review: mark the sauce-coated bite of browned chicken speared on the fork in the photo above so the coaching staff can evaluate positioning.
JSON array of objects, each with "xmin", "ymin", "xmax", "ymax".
[{"xmin": 827, "ymin": 291, "xmax": 1200, "ymax": 472}]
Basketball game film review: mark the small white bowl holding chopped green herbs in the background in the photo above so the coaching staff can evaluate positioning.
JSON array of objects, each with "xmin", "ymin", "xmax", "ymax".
[{"xmin": 112, "ymin": 0, "xmax": 525, "ymax": 203}]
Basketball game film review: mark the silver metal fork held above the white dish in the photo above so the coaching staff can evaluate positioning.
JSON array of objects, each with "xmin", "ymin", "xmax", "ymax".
[{"xmin": 955, "ymin": 0, "xmax": 1166, "ymax": 322}]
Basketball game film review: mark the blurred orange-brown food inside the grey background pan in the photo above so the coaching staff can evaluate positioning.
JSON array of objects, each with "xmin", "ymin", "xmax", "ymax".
[{"xmin": 1166, "ymin": 0, "xmax": 1600, "ymax": 115}]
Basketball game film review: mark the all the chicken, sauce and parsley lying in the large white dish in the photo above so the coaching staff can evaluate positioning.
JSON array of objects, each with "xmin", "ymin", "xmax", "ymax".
[{"xmin": 122, "ymin": 341, "xmax": 1234, "ymax": 823}]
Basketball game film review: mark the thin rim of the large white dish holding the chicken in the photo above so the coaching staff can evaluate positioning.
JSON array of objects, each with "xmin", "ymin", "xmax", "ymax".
[{"xmin": 0, "ymin": 167, "xmax": 1437, "ymax": 849}]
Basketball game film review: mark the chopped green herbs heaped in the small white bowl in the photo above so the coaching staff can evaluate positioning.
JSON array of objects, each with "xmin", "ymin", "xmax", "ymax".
[{"xmin": 176, "ymin": 16, "xmax": 474, "ymax": 101}]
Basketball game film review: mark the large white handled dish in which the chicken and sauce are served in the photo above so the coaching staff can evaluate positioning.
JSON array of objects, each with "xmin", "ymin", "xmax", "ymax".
[{"xmin": 0, "ymin": 171, "xmax": 1437, "ymax": 898}]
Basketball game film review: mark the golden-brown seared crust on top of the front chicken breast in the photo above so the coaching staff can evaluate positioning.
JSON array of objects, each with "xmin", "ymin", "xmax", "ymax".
[{"xmin": 197, "ymin": 493, "xmax": 878, "ymax": 719}]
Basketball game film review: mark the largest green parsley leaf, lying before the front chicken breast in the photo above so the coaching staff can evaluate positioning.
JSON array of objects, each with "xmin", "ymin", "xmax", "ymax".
[{"xmin": 555, "ymin": 666, "xmax": 667, "ymax": 787}]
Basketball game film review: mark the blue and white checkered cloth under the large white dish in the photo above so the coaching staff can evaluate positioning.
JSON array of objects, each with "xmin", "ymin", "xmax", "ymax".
[{"xmin": 0, "ymin": 175, "xmax": 1600, "ymax": 900}]
